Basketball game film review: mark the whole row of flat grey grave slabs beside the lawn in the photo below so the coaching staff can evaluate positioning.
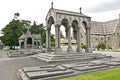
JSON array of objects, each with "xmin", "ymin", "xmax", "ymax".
[{"xmin": 19, "ymin": 58, "xmax": 120, "ymax": 80}]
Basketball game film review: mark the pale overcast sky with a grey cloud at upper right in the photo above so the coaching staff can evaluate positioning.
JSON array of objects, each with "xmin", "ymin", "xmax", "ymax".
[{"xmin": 0, "ymin": 0, "xmax": 120, "ymax": 30}]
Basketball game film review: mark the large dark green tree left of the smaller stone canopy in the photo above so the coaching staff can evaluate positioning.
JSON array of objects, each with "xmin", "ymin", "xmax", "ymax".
[{"xmin": 1, "ymin": 19, "xmax": 29, "ymax": 48}]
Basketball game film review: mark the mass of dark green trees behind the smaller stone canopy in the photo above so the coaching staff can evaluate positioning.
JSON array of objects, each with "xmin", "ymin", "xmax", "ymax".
[{"xmin": 0, "ymin": 13, "xmax": 55, "ymax": 48}]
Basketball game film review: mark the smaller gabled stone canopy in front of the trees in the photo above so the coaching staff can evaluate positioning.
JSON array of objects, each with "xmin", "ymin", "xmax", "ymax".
[{"xmin": 19, "ymin": 30, "xmax": 41, "ymax": 49}]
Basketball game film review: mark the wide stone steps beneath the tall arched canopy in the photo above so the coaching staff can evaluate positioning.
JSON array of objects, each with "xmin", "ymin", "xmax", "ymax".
[{"xmin": 36, "ymin": 53, "xmax": 110, "ymax": 62}]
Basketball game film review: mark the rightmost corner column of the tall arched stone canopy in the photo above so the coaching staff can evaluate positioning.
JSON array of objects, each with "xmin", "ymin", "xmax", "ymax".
[{"xmin": 86, "ymin": 23, "xmax": 92, "ymax": 53}]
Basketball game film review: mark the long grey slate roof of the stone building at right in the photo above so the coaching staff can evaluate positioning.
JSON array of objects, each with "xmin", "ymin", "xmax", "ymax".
[{"xmin": 91, "ymin": 19, "xmax": 119, "ymax": 35}]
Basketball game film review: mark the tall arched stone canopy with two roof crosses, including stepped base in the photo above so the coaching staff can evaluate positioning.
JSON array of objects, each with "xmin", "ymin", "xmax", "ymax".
[{"xmin": 36, "ymin": 2, "xmax": 96, "ymax": 62}]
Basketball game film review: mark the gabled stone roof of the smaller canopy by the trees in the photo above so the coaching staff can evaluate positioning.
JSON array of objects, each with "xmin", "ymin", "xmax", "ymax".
[{"xmin": 19, "ymin": 30, "xmax": 41, "ymax": 40}]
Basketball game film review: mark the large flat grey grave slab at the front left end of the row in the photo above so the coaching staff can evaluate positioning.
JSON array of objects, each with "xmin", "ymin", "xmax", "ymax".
[{"xmin": 19, "ymin": 65, "xmax": 74, "ymax": 80}]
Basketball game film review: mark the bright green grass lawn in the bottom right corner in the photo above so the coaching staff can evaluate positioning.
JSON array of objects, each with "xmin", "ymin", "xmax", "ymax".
[{"xmin": 59, "ymin": 67, "xmax": 120, "ymax": 80}]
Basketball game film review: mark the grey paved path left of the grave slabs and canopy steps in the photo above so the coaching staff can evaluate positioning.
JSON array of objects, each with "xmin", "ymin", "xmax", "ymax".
[{"xmin": 0, "ymin": 51, "xmax": 79, "ymax": 80}]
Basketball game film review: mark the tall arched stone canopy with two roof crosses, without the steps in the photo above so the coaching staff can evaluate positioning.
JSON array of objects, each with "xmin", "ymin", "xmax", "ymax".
[{"xmin": 46, "ymin": 2, "xmax": 92, "ymax": 53}]
